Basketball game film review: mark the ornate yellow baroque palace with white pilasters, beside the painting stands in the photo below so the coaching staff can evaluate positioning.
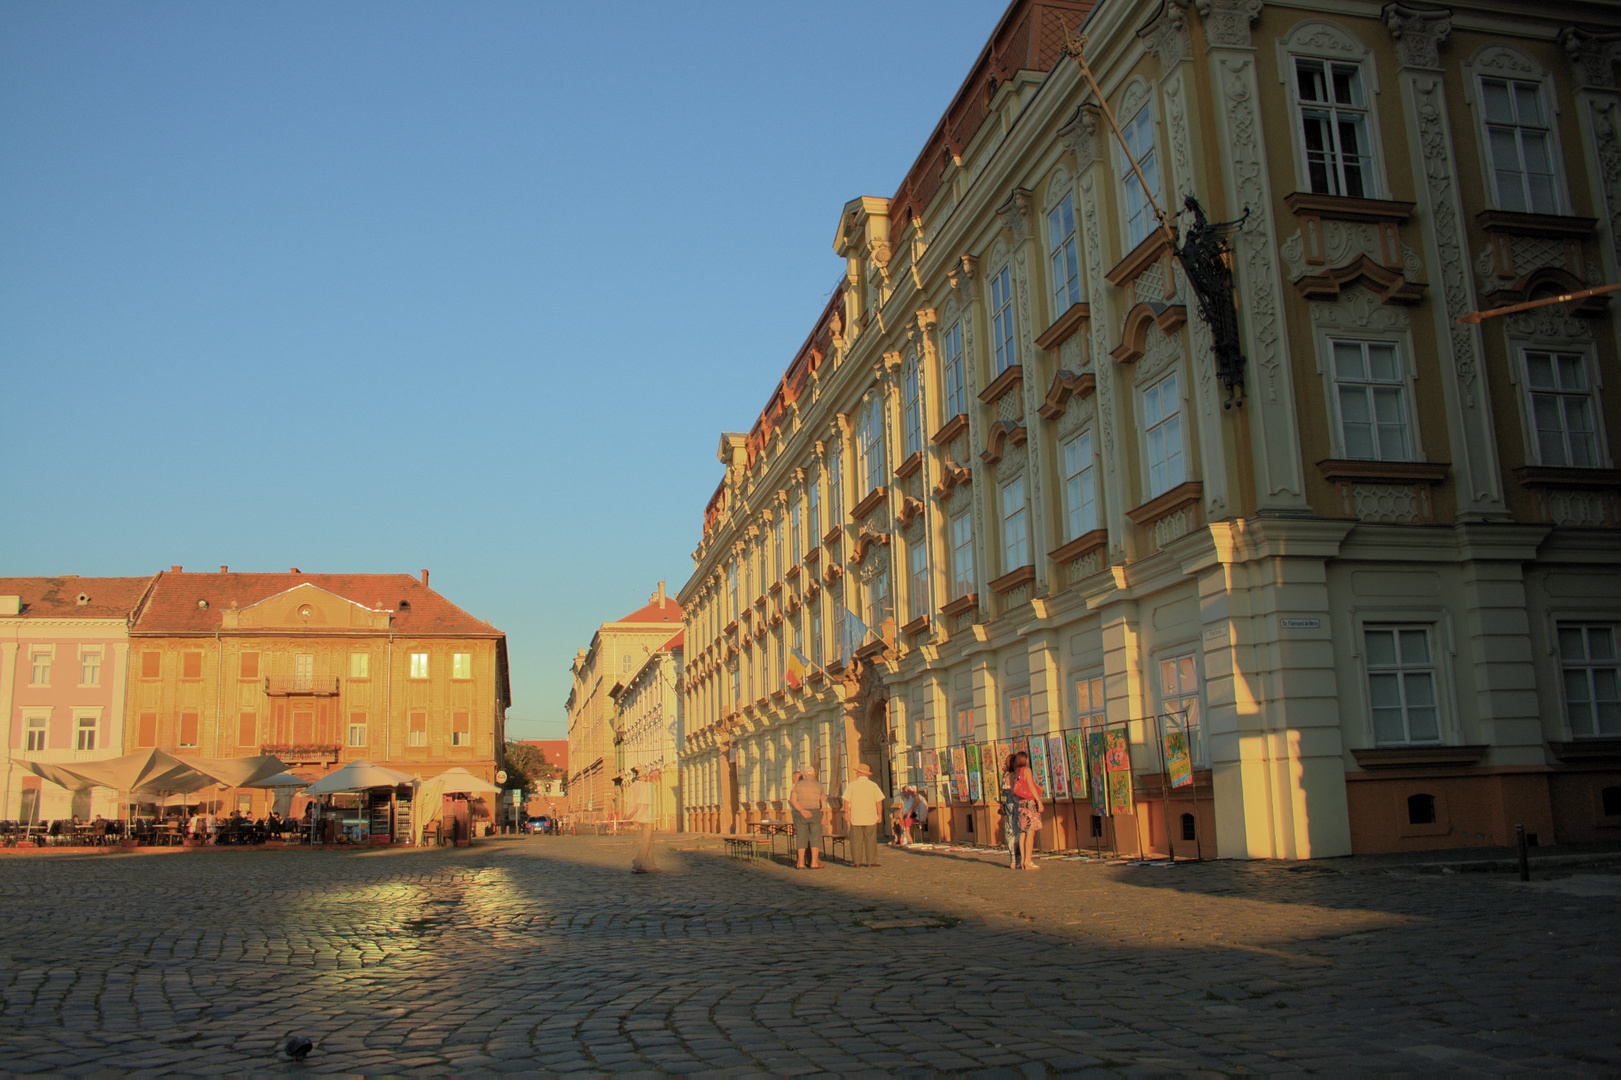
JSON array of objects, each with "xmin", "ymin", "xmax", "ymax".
[{"xmin": 679, "ymin": 0, "xmax": 1621, "ymax": 858}]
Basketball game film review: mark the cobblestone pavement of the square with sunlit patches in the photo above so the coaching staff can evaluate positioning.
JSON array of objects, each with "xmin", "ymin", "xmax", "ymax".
[{"xmin": 0, "ymin": 837, "xmax": 1621, "ymax": 1075}]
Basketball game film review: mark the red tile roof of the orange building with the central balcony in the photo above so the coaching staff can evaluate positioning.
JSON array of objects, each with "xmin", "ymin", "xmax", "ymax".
[{"xmin": 130, "ymin": 571, "xmax": 504, "ymax": 637}]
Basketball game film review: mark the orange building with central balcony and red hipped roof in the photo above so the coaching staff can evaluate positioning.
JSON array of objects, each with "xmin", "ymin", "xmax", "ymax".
[{"xmin": 125, "ymin": 566, "xmax": 512, "ymax": 812}]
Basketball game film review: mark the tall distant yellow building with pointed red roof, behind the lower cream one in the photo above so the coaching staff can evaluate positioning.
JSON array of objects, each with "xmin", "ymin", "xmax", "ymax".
[{"xmin": 564, "ymin": 582, "xmax": 681, "ymax": 824}]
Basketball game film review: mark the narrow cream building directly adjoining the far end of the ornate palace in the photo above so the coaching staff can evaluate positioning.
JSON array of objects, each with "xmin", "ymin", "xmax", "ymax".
[{"xmin": 609, "ymin": 631, "xmax": 684, "ymax": 832}]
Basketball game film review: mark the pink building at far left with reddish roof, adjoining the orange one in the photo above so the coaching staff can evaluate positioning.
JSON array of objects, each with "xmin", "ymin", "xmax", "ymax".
[{"xmin": 0, "ymin": 576, "xmax": 154, "ymax": 821}]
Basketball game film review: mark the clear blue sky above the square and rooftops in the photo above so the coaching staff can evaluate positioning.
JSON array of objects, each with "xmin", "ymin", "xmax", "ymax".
[{"xmin": 0, "ymin": 0, "xmax": 1002, "ymax": 738}]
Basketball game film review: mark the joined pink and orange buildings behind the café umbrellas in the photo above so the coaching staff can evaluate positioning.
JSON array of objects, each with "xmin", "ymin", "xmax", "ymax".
[{"xmin": 0, "ymin": 566, "xmax": 511, "ymax": 821}]
